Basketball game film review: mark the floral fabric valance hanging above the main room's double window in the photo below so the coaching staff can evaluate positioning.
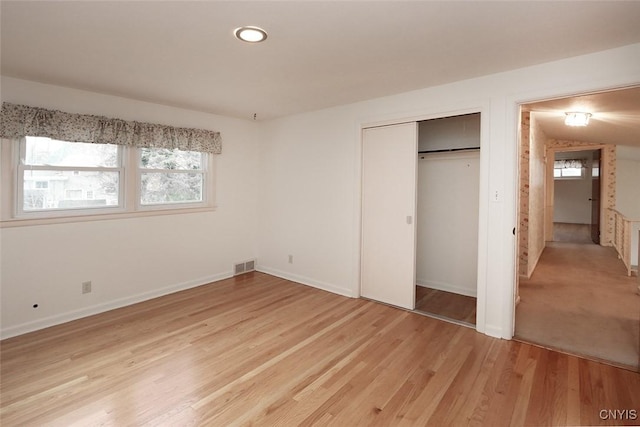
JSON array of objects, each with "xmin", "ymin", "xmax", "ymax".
[{"xmin": 0, "ymin": 102, "xmax": 222, "ymax": 154}]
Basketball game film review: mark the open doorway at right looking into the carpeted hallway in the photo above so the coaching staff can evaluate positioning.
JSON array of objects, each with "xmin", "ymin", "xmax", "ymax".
[{"xmin": 514, "ymin": 88, "xmax": 640, "ymax": 370}]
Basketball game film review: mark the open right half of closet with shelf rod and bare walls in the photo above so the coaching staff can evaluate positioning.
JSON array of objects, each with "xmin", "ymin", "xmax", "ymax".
[{"xmin": 415, "ymin": 113, "xmax": 480, "ymax": 325}]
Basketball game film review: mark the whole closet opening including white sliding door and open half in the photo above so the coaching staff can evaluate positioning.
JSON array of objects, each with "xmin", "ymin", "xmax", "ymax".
[{"xmin": 360, "ymin": 113, "xmax": 480, "ymax": 327}]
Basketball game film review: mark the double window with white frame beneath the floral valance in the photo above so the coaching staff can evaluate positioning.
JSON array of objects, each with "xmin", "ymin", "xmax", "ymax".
[{"xmin": 3, "ymin": 137, "xmax": 213, "ymax": 219}]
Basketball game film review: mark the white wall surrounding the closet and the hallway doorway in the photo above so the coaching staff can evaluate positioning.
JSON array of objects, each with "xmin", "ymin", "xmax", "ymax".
[{"xmin": 258, "ymin": 44, "xmax": 640, "ymax": 338}]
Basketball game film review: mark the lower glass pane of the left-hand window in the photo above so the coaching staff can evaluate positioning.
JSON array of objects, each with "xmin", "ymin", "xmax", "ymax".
[{"xmin": 22, "ymin": 170, "xmax": 120, "ymax": 211}]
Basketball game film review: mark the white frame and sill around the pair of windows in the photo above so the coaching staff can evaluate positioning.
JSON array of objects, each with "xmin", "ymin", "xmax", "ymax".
[{"xmin": 0, "ymin": 138, "xmax": 217, "ymax": 228}]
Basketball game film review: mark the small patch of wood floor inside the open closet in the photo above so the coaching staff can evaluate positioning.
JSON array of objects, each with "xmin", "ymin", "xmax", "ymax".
[{"xmin": 415, "ymin": 286, "xmax": 476, "ymax": 325}]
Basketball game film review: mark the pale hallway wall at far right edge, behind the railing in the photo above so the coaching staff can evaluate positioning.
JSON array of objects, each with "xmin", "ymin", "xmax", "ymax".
[{"xmin": 616, "ymin": 146, "xmax": 640, "ymax": 265}]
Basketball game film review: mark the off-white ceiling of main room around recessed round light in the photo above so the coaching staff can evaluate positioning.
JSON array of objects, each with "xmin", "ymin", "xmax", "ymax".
[{"xmin": 0, "ymin": 0, "xmax": 640, "ymax": 119}]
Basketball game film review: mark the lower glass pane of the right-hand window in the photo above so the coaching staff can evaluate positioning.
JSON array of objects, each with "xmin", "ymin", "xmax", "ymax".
[{"xmin": 140, "ymin": 172, "xmax": 203, "ymax": 205}]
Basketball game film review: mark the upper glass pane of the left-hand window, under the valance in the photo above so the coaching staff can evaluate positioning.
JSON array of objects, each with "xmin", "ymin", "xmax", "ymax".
[{"xmin": 25, "ymin": 136, "xmax": 118, "ymax": 167}]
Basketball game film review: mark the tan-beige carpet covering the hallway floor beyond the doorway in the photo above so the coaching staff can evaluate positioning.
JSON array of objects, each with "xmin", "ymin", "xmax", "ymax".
[{"xmin": 516, "ymin": 242, "xmax": 640, "ymax": 370}]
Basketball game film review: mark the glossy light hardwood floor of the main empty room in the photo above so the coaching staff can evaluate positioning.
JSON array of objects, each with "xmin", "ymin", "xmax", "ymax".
[{"xmin": 0, "ymin": 273, "xmax": 640, "ymax": 427}]
